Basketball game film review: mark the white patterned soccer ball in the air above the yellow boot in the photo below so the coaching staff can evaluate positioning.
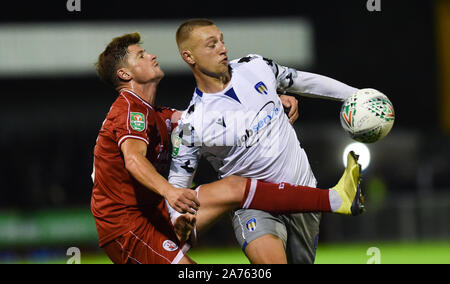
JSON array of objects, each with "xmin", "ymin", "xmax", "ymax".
[{"xmin": 340, "ymin": 89, "xmax": 395, "ymax": 143}]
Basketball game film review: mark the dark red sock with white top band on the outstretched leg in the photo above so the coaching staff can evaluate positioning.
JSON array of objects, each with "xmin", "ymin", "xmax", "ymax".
[{"xmin": 241, "ymin": 179, "xmax": 331, "ymax": 213}]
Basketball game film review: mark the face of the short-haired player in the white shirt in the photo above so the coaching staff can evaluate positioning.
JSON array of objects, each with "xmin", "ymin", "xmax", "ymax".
[{"xmin": 191, "ymin": 26, "xmax": 228, "ymax": 77}]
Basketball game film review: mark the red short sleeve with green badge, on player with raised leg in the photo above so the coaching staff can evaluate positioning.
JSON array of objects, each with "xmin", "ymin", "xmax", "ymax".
[{"xmin": 113, "ymin": 97, "xmax": 149, "ymax": 147}]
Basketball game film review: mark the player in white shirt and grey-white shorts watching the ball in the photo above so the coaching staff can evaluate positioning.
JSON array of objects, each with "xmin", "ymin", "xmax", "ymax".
[{"xmin": 169, "ymin": 19, "xmax": 361, "ymax": 263}]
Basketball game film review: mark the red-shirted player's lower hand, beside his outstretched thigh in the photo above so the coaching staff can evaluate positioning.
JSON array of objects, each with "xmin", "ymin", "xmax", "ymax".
[{"xmin": 164, "ymin": 187, "xmax": 200, "ymax": 214}]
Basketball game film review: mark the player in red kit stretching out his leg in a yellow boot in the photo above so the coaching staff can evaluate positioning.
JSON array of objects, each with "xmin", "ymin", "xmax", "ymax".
[{"xmin": 91, "ymin": 33, "xmax": 359, "ymax": 263}]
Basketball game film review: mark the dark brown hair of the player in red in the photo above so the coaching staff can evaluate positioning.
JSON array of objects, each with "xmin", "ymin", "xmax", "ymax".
[{"xmin": 95, "ymin": 32, "xmax": 141, "ymax": 88}]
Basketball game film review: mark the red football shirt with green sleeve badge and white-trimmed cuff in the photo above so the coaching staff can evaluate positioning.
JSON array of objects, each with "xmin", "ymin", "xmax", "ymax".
[{"xmin": 91, "ymin": 91, "xmax": 174, "ymax": 246}]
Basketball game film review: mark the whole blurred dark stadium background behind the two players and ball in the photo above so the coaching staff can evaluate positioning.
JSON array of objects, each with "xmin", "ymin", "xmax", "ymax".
[{"xmin": 0, "ymin": 0, "xmax": 450, "ymax": 263}]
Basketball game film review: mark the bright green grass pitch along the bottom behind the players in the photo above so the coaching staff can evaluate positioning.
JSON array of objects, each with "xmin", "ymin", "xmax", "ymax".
[{"xmin": 4, "ymin": 241, "xmax": 450, "ymax": 264}]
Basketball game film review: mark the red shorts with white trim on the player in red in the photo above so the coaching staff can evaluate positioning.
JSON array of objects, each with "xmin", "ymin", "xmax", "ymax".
[{"xmin": 103, "ymin": 211, "xmax": 191, "ymax": 264}]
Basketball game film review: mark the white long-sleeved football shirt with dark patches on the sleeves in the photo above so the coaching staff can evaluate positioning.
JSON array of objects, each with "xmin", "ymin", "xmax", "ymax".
[{"xmin": 169, "ymin": 54, "xmax": 357, "ymax": 187}]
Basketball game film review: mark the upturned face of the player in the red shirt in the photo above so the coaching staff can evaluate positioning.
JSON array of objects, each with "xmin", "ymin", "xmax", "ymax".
[{"xmin": 127, "ymin": 44, "xmax": 164, "ymax": 84}]
